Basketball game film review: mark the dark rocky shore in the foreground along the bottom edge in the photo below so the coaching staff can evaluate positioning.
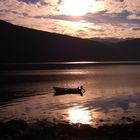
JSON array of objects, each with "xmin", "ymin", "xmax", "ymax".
[{"xmin": 0, "ymin": 120, "xmax": 140, "ymax": 140}]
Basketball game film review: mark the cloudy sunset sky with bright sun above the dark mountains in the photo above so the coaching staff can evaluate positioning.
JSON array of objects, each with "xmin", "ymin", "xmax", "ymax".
[{"xmin": 0, "ymin": 0, "xmax": 140, "ymax": 39}]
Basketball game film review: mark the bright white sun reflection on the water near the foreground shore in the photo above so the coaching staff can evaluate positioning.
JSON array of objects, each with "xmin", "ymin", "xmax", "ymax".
[{"xmin": 68, "ymin": 106, "xmax": 92, "ymax": 124}]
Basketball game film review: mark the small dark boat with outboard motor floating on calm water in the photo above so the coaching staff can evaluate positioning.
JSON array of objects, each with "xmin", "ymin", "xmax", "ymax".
[{"xmin": 53, "ymin": 86, "xmax": 85, "ymax": 96}]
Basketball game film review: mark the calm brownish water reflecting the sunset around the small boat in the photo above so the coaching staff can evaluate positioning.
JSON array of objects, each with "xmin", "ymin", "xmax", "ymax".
[{"xmin": 0, "ymin": 62, "xmax": 140, "ymax": 127}]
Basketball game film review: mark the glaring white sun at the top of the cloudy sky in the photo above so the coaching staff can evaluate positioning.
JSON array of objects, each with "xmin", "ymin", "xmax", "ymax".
[{"xmin": 60, "ymin": 0, "xmax": 94, "ymax": 16}]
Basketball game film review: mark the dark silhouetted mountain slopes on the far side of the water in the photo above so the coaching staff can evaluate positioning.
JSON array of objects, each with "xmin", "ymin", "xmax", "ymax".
[{"xmin": 0, "ymin": 20, "xmax": 140, "ymax": 62}]
